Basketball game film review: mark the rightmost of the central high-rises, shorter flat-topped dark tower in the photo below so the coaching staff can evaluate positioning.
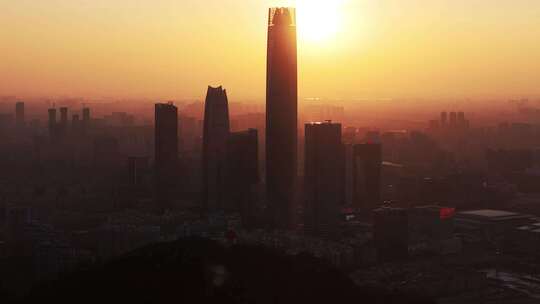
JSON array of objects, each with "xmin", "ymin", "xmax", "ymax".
[{"xmin": 353, "ymin": 144, "xmax": 382, "ymax": 211}]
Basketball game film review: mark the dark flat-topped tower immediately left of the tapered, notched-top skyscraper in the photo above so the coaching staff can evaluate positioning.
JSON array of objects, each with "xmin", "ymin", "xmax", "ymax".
[{"xmin": 154, "ymin": 103, "xmax": 178, "ymax": 211}]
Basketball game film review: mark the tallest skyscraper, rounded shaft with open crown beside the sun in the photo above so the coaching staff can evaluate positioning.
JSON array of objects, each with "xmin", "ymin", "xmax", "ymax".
[{"xmin": 266, "ymin": 8, "xmax": 298, "ymax": 229}]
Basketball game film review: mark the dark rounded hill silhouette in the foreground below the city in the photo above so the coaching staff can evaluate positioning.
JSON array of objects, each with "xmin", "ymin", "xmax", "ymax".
[{"xmin": 20, "ymin": 239, "xmax": 432, "ymax": 304}]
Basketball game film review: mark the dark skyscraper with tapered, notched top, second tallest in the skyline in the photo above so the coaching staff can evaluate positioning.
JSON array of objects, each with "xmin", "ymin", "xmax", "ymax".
[{"xmin": 202, "ymin": 87, "xmax": 230, "ymax": 211}]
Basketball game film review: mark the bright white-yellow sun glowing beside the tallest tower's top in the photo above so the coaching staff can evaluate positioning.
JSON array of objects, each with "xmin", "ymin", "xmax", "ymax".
[{"xmin": 296, "ymin": 0, "xmax": 346, "ymax": 42}]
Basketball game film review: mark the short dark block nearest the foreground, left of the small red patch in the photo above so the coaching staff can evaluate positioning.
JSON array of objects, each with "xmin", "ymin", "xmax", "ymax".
[{"xmin": 373, "ymin": 208, "xmax": 409, "ymax": 262}]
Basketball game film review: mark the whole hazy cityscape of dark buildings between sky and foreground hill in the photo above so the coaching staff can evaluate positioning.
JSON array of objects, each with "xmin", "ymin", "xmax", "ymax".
[{"xmin": 0, "ymin": 8, "xmax": 540, "ymax": 302}]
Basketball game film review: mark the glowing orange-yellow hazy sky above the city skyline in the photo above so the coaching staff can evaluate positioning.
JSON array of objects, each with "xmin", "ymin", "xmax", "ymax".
[{"xmin": 0, "ymin": 0, "xmax": 540, "ymax": 100}]
